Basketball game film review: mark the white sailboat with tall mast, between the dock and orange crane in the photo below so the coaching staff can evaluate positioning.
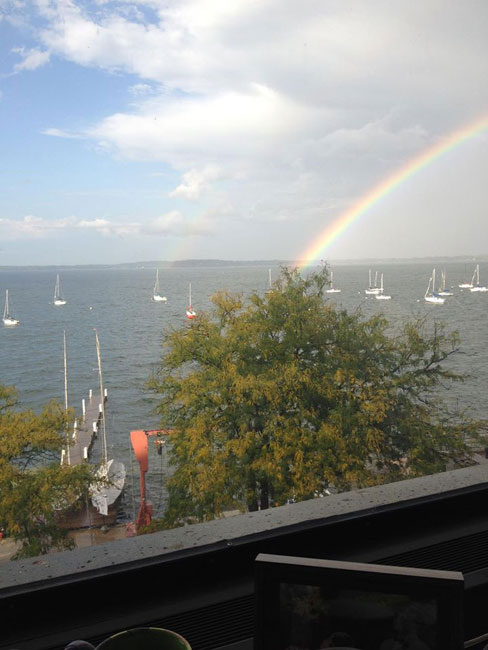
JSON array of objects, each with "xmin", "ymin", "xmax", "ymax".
[{"xmin": 90, "ymin": 330, "xmax": 125, "ymax": 516}]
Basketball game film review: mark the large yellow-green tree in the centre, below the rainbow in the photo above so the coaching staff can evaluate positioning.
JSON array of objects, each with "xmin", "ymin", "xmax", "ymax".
[{"xmin": 150, "ymin": 266, "xmax": 479, "ymax": 524}]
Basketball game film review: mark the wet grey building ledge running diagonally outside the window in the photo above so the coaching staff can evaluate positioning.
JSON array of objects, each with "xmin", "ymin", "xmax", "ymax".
[{"xmin": 0, "ymin": 463, "xmax": 488, "ymax": 595}]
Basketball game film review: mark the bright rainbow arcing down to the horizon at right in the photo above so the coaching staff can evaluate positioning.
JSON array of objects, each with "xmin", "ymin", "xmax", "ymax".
[{"xmin": 297, "ymin": 115, "xmax": 488, "ymax": 267}]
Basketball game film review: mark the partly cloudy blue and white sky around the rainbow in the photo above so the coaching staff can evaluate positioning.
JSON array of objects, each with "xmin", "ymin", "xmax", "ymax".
[{"xmin": 0, "ymin": 0, "xmax": 488, "ymax": 266}]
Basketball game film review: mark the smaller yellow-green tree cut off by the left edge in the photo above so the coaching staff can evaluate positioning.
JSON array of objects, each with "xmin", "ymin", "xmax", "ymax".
[{"xmin": 0, "ymin": 385, "xmax": 93, "ymax": 558}]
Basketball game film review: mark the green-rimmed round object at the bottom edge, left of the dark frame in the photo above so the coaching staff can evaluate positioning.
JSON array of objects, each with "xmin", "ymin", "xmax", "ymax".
[{"xmin": 96, "ymin": 627, "xmax": 191, "ymax": 650}]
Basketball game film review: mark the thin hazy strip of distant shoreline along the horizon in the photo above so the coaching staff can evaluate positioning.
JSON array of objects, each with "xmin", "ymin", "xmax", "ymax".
[{"xmin": 0, "ymin": 255, "xmax": 488, "ymax": 271}]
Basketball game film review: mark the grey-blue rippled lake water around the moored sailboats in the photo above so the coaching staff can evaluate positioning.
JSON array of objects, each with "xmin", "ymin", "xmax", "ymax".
[{"xmin": 0, "ymin": 263, "xmax": 488, "ymax": 517}]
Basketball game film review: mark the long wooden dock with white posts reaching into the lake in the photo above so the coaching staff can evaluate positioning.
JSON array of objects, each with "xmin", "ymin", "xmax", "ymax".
[{"xmin": 61, "ymin": 389, "xmax": 107, "ymax": 466}]
